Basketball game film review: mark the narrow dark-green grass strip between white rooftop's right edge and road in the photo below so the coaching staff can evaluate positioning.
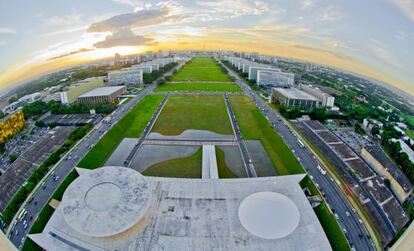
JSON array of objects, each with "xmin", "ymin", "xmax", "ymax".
[{"xmin": 301, "ymin": 176, "xmax": 350, "ymax": 251}]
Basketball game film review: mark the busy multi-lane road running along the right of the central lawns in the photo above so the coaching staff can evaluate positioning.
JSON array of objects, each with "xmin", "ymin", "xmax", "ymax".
[{"xmin": 223, "ymin": 60, "xmax": 375, "ymax": 251}]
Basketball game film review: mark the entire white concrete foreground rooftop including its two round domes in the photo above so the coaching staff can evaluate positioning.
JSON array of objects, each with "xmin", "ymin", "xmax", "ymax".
[{"xmin": 29, "ymin": 167, "xmax": 332, "ymax": 251}]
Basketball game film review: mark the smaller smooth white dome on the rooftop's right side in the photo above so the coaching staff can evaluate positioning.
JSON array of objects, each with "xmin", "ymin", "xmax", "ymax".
[{"xmin": 239, "ymin": 192, "xmax": 300, "ymax": 239}]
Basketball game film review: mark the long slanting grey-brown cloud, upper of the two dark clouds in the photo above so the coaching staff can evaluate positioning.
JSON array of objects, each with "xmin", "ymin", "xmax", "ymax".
[{"xmin": 88, "ymin": 8, "xmax": 182, "ymax": 32}]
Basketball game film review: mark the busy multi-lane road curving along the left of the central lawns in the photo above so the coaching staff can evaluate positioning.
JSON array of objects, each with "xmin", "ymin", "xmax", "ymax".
[{"xmin": 9, "ymin": 61, "xmax": 183, "ymax": 249}]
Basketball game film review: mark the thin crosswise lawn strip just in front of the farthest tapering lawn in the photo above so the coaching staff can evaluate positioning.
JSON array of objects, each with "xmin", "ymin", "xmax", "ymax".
[{"xmin": 154, "ymin": 83, "xmax": 242, "ymax": 92}]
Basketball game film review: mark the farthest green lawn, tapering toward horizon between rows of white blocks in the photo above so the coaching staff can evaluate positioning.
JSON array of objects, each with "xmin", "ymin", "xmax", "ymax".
[{"xmin": 171, "ymin": 58, "xmax": 231, "ymax": 82}]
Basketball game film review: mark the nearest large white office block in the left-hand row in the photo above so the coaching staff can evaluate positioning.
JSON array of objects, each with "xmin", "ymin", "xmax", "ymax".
[{"xmin": 108, "ymin": 68, "xmax": 144, "ymax": 85}]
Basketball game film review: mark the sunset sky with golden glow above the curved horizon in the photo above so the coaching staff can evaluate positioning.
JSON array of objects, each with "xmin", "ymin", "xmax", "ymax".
[{"xmin": 0, "ymin": 0, "xmax": 414, "ymax": 95}]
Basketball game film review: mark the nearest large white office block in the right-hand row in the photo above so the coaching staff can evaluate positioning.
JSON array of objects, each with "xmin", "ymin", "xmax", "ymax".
[{"xmin": 256, "ymin": 69, "xmax": 295, "ymax": 87}]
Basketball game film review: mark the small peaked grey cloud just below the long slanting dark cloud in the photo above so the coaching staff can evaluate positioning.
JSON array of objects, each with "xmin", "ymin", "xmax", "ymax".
[{"xmin": 94, "ymin": 28, "xmax": 154, "ymax": 48}]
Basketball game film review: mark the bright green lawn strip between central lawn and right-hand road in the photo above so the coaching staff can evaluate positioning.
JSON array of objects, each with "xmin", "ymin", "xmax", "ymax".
[{"xmin": 229, "ymin": 95, "xmax": 304, "ymax": 175}]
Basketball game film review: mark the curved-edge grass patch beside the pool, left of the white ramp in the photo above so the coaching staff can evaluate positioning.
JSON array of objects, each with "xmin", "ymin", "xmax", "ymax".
[{"xmin": 142, "ymin": 147, "xmax": 202, "ymax": 178}]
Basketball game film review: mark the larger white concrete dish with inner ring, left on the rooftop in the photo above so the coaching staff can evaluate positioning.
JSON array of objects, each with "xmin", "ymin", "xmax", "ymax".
[{"xmin": 61, "ymin": 166, "xmax": 150, "ymax": 237}]
